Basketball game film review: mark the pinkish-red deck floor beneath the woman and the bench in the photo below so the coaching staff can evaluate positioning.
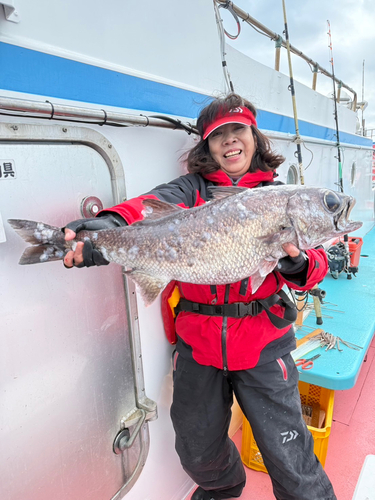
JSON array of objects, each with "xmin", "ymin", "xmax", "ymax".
[{"xmin": 233, "ymin": 334, "xmax": 375, "ymax": 500}]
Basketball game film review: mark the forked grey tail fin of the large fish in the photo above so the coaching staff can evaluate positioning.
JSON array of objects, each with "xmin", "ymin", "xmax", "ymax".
[{"xmin": 8, "ymin": 219, "xmax": 67, "ymax": 265}]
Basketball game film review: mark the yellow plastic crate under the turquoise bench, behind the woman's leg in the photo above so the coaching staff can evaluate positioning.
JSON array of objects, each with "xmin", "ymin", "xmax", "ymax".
[{"xmin": 241, "ymin": 382, "xmax": 335, "ymax": 472}]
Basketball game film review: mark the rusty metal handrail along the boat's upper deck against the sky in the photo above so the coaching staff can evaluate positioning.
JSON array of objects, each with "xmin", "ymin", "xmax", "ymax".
[{"xmin": 215, "ymin": 0, "xmax": 357, "ymax": 111}]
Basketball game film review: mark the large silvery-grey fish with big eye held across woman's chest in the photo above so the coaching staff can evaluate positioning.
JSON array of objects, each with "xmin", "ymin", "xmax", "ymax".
[{"xmin": 9, "ymin": 185, "xmax": 362, "ymax": 305}]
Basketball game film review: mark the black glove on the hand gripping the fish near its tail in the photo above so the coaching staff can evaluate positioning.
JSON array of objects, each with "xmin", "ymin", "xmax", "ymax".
[{"xmin": 63, "ymin": 213, "xmax": 127, "ymax": 267}]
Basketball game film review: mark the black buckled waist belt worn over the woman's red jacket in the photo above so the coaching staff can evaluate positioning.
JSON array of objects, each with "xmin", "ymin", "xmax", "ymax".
[{"xmin": 174, "ymin": 290, "xmax": 297, "ymax": 330}]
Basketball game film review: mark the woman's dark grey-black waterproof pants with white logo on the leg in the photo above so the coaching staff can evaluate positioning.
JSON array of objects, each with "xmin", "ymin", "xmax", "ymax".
[{"xmin": 171, "ymin": 354, "xmax": 336, "ymax": 500}]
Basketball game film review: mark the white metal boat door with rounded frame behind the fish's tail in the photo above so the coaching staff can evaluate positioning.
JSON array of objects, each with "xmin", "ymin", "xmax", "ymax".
[{"xmin": 0, "ymin": 123, "xmax": 156, "ymax": 500}]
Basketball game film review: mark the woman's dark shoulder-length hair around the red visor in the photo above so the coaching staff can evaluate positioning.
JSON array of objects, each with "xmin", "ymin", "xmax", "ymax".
[{"xmin": 187, "ymin": 93, "xmax": 285, "ymax": 174}]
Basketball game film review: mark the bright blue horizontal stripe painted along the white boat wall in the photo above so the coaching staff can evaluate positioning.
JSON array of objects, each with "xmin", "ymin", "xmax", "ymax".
[{"xmin": 0, "ymin": 42, "xmax": 372, "ymax": 147}]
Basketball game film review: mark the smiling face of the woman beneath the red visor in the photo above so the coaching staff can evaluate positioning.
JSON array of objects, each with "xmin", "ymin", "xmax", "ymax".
[{"xmin": 208, "ymin": 123, "xmax": 256, "ymax": 177}]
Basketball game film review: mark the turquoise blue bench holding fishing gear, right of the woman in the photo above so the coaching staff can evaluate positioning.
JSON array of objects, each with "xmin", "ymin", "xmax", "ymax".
[{"xmin": 296, "ymin": 228, "xmax": 375, "ymax": 390}]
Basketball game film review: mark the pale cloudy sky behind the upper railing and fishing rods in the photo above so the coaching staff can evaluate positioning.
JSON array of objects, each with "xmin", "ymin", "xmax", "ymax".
[{"xmin": 220, "ymin": 0, "xmax": 375, "ymax": 133}]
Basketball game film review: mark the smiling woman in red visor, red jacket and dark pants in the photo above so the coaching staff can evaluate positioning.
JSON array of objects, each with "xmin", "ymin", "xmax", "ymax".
[{"xmin": 64, "ymin": 94, "xmax": 336, "ymax": 500}]
